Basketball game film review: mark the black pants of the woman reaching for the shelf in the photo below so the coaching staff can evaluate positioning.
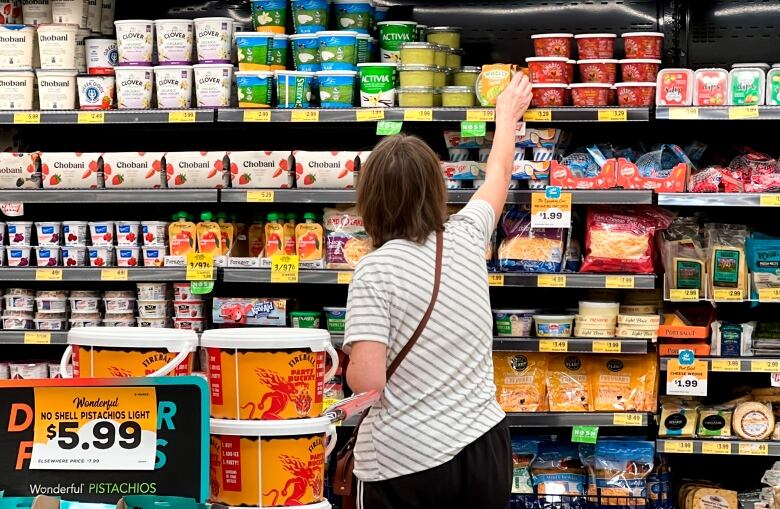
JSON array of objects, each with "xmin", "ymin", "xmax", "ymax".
[{"xmin": 357, "ymin": 419, "xmax": 512, "ymax": 509}]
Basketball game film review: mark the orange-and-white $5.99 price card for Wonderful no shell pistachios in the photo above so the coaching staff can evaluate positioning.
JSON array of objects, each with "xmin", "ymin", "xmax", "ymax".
[{"xmin": 30, "ymin": 387, "xmax": 157, "ymax": 470}]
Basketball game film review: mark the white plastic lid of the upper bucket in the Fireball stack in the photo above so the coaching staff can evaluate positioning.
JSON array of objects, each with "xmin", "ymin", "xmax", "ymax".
[{"xmin": 200, "ymin": 327, "xmax": 330, "ymax": 352}]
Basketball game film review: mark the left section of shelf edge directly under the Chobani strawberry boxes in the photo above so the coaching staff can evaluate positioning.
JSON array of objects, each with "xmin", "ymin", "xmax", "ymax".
[{"xmin": 0, "ymin": 189, "xmax": 219, "ymax": 203}]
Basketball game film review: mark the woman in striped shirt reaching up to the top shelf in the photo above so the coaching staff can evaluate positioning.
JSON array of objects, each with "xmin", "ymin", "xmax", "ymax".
[{"xmin": 344, "ymin": 73, "xmax": 531, "ymax": 509}]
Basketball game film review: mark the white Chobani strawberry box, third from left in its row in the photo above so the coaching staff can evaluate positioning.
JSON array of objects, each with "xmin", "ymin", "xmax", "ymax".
[{"xmin": 103, "ymin": 152, "xmax": 163, "ymax": 189}]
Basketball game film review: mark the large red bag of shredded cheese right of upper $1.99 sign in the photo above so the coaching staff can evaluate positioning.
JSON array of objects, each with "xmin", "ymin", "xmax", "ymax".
[{"xmin": 580, "ymin": 205, "xmax": 674, "ymax": 274}]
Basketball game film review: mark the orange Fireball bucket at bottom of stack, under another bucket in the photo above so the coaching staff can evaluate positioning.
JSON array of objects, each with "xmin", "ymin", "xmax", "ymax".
[{"xmin": 209, "ymin": 417, "xmax": 336, "ymax": 509}]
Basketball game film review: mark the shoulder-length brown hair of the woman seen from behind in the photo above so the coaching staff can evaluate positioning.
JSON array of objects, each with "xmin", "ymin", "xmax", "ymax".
[{"xmin": 357, "ymin": 134, "xmax": 447, "ymax": 248}]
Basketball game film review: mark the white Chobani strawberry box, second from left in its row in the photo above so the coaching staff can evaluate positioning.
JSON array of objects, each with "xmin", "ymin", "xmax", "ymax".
[{"xmin": 40, "ymin": 152, "xmax": 100, "ymax": 189}]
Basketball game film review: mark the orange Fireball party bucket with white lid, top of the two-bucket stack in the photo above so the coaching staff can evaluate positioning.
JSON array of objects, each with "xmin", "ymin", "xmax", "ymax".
[{"xmin": 200, "ymin": 328, "xmax": 338, "ymax": 421}]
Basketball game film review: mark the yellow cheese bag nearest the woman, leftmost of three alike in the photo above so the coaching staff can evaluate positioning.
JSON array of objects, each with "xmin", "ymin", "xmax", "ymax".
[{"xmin": 493, "ymin": 352, "xmax": 547, "ymax": 412}]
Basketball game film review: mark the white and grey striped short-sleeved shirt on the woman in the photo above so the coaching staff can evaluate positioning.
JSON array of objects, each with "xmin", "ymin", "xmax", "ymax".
[{"xmin": 344, "ymin": 201, "xmax": 504, "ymax": 481}]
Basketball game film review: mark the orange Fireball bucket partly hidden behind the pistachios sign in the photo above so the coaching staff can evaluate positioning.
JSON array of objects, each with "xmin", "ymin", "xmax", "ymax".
[{"xmin": 60, "ymin": 327, "xmax": 198, "ymax": 378}]
